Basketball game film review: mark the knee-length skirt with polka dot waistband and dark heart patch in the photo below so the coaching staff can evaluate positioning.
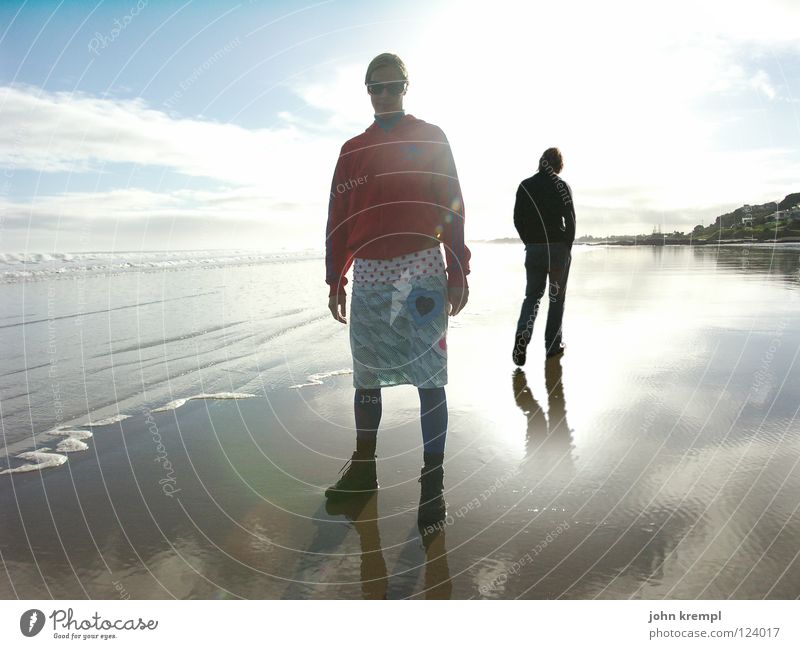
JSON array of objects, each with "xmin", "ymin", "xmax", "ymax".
[{"xmin": 350, "ymin": 246, "xmax": 448, "ymax": 388}]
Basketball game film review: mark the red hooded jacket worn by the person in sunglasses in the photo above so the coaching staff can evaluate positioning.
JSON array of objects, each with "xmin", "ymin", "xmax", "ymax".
[{"xmin": 325, "ymin": 115, "xmax": 471, "ymax": 295}]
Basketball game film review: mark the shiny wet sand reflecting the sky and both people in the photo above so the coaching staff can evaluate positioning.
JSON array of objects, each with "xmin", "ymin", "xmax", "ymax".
[{"xmin": 0, "ymin": 247, "xmax": 800, "ymax": 599}]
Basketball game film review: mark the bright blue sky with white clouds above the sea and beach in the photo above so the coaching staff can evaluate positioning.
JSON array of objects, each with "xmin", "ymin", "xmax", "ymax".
[{"xmin": 0, "ymin": 0, "xmax": 800, "ymax": 252}]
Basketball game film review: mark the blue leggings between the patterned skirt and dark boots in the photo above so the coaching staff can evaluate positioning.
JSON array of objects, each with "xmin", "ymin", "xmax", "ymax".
[{"xmin": 353, "ymin": 388, "xmax": 447, "ymax": 454}]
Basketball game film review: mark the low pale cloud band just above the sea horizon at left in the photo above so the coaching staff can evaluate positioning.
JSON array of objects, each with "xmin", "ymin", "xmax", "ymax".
[{"xmin": 0, "ymin": 187, "xmax": 318, "ymax": 251}]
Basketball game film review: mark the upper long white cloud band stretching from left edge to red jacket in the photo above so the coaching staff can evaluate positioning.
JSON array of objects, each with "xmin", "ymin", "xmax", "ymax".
[{"xmin": 0, "ymin": 86, "xmax": 340, "ymax": 191}]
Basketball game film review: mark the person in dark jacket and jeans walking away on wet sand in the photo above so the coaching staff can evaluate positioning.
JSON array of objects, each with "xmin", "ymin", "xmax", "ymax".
[{"xmin": 512, "ymin": 148, "xmax": 575, "ymax": 365}]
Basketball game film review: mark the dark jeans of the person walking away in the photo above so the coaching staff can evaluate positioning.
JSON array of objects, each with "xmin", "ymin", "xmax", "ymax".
[{"xmin": 517, "ymin": 242, "xmax": 572, "ymax": 351}]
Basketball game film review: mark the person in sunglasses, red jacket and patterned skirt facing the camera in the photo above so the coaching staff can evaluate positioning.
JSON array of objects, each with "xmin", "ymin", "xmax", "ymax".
[{"xmin": 325, "ymin": 54, "xmax": 470, "ymax": 523}]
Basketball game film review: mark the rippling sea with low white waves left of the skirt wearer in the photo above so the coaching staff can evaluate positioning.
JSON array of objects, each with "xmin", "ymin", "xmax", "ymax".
[{"xmin": 0, "ymin": 250, "xmax": 349, "ymax": 460}]
